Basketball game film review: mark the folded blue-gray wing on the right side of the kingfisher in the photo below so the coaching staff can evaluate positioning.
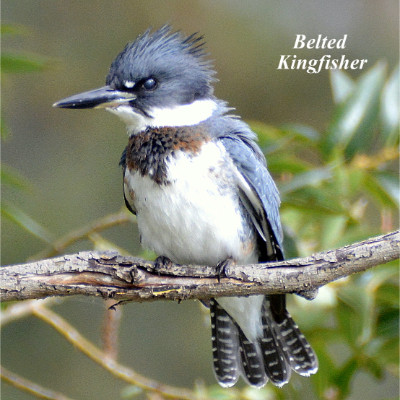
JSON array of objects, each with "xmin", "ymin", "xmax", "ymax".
[{"xmin": 218, "ymin": 120, "xmax": 283, "ymax": 260}]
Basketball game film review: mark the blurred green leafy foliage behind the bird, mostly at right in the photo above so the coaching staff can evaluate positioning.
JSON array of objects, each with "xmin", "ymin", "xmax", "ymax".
[{"xmin": 2, "ymin": 41, "xmax": 400, "ymax": 400}]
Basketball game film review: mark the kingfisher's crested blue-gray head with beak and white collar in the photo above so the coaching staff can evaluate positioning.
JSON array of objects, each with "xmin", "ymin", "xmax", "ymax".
[{"xmin": 54, "ymin": 25, "xmax": 218, "ymax": 134}]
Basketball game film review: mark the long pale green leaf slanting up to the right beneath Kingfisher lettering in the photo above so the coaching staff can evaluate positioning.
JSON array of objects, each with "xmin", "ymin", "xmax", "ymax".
[{"xmin": 324, "ymin": 62, "xmax": 386, "ymax": 155}]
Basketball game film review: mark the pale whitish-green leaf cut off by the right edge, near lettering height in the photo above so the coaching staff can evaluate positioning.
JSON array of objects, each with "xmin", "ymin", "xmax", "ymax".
[{"xmin": 381, "ymin": 66, "xmax": 400, "ymax": 146}]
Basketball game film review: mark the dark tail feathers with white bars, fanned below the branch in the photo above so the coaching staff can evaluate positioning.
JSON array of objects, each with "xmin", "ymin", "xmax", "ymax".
[{"xmin": 210, "ymin": 295, "xmax": 318, "ymax": 387}]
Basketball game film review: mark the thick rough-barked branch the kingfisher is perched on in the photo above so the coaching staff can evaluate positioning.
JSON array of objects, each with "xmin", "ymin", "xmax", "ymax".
[{"xmin": 0, "ymin": 231, "xmax": 400, "ymax": 301}]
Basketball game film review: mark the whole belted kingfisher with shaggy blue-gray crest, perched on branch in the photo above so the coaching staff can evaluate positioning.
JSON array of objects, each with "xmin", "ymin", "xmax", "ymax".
[{"xmin": 54, "ymin": 25, "xmax": 318, "ymax": 387}]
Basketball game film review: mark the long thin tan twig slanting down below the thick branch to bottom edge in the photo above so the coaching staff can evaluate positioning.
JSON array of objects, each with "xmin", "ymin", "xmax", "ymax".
[{"xmin": 32, "ymin": 304, "xmax": 199, "ymax": 400}]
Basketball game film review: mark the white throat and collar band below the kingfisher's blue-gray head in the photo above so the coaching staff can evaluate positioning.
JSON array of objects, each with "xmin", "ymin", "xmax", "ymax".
[{"xmin": 107, "ymin": 99, "xmax": 218, "ymax": 134}]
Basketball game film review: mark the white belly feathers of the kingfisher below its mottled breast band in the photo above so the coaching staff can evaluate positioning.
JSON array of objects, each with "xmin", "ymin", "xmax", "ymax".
[{"xmin": 125, "ymin": 142, "xmax": 257, "ymax": 265}]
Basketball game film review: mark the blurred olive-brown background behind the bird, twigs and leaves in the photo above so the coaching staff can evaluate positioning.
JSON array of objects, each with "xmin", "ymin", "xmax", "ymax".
[{"xmin": 1, "ymin": 0, "xmax": 398, "ymax": 399}]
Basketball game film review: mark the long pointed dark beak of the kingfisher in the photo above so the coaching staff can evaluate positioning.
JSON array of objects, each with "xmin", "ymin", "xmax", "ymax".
[{"xmin": 53, "ymin": 86, "xmax": 136, "ymax": 109}]
